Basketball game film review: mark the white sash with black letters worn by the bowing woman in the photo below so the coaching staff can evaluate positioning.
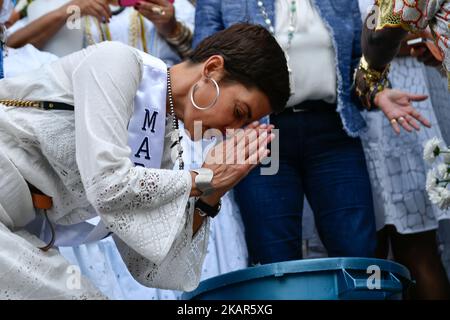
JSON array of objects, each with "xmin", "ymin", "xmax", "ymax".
[{"xmin": 46, "ymin": 51, "xmax": 167, "ymax": 246}]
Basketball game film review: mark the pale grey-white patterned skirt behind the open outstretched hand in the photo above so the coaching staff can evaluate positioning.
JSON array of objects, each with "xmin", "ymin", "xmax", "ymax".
[{"xmin": 361, "ymin": 58, "xmax": 450, "ymax": 234}]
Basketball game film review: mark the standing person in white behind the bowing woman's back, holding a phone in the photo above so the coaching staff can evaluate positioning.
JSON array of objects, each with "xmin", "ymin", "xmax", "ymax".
[{"xmin": 8, "ymin": 0, "xmax": 194, "ymax": 58}]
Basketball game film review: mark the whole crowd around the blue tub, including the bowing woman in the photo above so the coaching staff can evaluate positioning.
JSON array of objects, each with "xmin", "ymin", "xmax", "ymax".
[{"xmin": 0, "ymin": 0, "xmax": 450, "ymax": 299}]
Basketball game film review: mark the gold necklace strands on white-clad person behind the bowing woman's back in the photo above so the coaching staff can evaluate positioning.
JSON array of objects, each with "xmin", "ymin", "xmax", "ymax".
[{"xmin": 84, "ymin": 11, "xmax": 148, "ymax": 53}]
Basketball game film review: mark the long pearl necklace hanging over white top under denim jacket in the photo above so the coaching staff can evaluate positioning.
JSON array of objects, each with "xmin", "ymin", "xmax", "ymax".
[{"xmin": 257, "ymin": 0, "xmax": 297, "ymax": 95}]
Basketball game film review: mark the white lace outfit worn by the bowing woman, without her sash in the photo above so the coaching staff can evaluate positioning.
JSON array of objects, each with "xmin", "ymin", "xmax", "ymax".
[{"xmin": 0, "ymin": 43, "xmax": 209, "ymax": 299}]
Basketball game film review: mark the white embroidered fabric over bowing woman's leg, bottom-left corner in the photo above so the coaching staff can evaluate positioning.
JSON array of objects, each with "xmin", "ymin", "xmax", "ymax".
[{"xmin": 0, "ymin": 222, "xmax": 106, "ymax": 300}]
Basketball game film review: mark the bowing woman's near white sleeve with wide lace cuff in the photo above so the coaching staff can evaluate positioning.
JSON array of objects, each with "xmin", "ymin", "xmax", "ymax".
[{"xmin": 73, "ymin": 43, "xmax": 207, "ymax": 287}]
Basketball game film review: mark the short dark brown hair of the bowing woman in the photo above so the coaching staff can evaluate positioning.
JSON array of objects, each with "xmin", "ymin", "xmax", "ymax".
[{"xmin": 189, "ymin": 23, "xmax": 290, "ymax": 113}]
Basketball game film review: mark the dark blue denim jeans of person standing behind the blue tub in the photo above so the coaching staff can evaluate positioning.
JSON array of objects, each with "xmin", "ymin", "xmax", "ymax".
[{"xmin": 235, "ymin": 107, "xmax": 376, "ymax": 264}]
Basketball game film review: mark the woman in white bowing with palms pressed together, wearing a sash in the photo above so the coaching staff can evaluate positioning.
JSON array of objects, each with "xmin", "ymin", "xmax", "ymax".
[{"xmin": 0, "ymin": 24, "xmax": 289, "ymax": 299}]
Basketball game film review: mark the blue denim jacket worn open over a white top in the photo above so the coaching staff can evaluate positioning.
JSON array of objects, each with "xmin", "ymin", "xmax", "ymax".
[{"xmin": 194, "ymin": 0, "xmax": 365, "ymax": 137}]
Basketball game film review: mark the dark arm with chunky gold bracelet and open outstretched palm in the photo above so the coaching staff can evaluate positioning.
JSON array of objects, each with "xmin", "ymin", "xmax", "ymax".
[{"xmin": 355, "ymin": 0, "xmax": 442, "ymax": 133}]
